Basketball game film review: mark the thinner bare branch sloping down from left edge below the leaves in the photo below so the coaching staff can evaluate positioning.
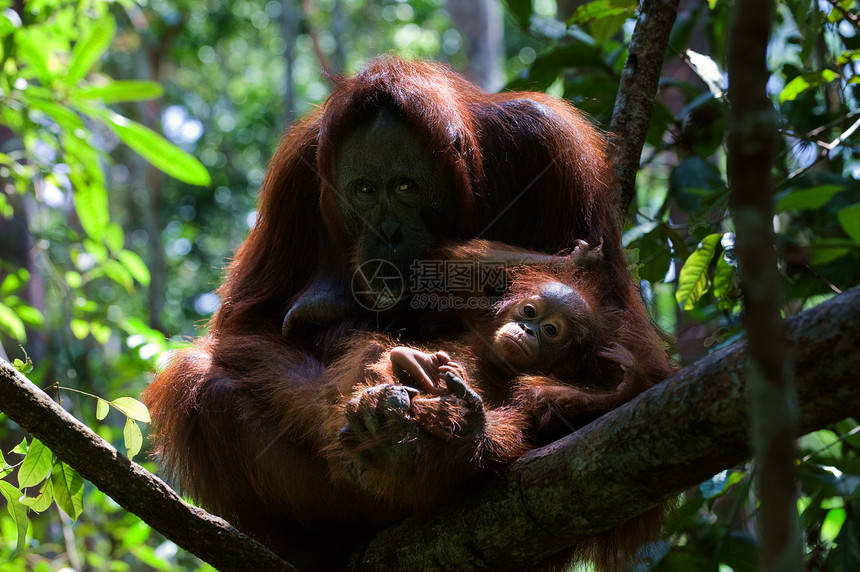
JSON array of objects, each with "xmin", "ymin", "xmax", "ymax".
[{"xmin": 0, "ymin": 360, "xmax": 295, "ymax": 571}]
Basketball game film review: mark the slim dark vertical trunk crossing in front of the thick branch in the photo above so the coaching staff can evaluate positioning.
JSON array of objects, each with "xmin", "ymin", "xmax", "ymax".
[{"xmin": 727, "ymin": 0, "xmax": 803, "ymax": 572}]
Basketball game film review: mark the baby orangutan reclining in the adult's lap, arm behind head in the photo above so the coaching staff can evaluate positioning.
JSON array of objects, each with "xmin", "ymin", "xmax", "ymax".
[{"xmin": 360, "ymin": 265, "xmax": 653, "ymax": 443}]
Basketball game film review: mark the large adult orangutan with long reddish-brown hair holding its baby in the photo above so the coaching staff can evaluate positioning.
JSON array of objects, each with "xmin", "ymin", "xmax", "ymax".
[{"xmin": 144, "ymin": 56, "xmax": 676, "ymax": 570}]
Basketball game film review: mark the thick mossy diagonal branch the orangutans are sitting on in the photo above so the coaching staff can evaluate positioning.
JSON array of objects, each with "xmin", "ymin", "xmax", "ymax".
[{"xmin": 353, "ymin": 287, "xmax": 860, "ymax": 571}]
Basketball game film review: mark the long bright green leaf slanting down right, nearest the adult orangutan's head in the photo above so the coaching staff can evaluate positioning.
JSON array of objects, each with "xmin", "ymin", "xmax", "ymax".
[{"xmin": 100, "ymin": 110, "xmax": 212, "ymax": 187}]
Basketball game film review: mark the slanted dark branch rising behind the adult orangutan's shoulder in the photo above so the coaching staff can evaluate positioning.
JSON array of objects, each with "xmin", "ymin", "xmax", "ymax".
[{"xmin": 609, "ymin": 0, "xmax": 678, "ymax": 224}]
